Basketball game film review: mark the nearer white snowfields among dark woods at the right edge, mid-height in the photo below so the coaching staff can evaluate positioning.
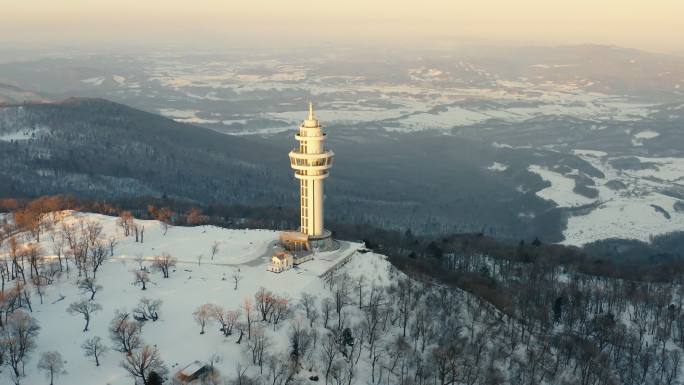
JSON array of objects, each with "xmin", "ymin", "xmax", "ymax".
[{"xmin": 529, "ymin": 150, "xmax": 684, "ymax": 245}]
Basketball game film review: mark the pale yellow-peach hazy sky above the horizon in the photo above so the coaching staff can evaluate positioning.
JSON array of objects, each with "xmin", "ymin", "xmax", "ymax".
[{"xmin": 0, "ymin": 0, "xmax": 684, "ymax": 52}]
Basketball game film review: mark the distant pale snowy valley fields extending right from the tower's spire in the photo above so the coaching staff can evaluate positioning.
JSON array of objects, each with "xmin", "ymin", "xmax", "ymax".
[{"xmin": 255, "ymin": 86, "xmax": 653, "ymax": 134}]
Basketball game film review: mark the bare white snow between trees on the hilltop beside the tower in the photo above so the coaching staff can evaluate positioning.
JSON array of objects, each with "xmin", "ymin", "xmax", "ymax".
[{"xmin": 0, "ymin": 213, "xmax": 368, "ymax": 385}]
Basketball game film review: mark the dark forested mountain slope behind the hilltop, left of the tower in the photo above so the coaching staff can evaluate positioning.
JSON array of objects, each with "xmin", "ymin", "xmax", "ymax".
[{"xmin": 0, "ymin": 99, "xmax": 288, "ymax": 203}]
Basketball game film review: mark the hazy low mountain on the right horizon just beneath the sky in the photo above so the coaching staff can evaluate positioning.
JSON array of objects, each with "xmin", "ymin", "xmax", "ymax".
[{"xmin": 468, "ymin": 44, "xmax": 684, "ymax": 98}]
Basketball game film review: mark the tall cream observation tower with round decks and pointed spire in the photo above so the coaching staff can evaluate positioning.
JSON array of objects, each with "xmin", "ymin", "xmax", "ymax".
[{"xmin": 289, "ymin": 103, "xmax": 335, "ymax": 244}]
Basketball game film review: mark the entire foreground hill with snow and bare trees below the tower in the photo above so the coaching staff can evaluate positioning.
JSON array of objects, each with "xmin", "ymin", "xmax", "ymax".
[{"xmin": 0, "ymin": 211, "xmax": 684, "ymax": 385}]
